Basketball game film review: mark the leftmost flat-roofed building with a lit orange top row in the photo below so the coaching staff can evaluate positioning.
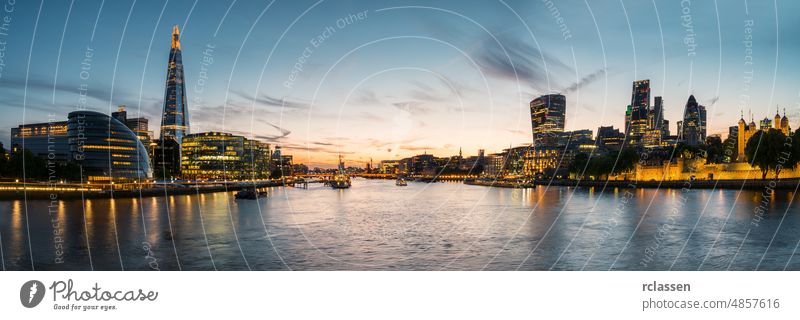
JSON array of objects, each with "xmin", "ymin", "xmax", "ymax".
[{"xmin": 11, "ymin": 121, "xmax": 69, "ymax": 162}]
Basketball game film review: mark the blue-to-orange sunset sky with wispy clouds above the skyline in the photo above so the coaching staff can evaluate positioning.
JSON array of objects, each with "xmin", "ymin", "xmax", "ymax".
[{"xmin": 0, "ymin": 0, "xmax": 800, "ymax": 167}]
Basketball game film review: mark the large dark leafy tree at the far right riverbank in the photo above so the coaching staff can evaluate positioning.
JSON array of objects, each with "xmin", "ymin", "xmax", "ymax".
[{"xmin": 744, "ymin": 129, "xmax": 800, "ymax": 179}]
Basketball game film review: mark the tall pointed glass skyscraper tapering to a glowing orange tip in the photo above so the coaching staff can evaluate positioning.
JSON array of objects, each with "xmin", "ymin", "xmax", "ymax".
[{"xmin": 159, "ymin": 25, "xmax": 189, "ymax": 145}]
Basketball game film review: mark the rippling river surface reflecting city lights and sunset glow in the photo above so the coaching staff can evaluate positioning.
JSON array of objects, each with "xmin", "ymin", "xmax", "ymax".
[{"xmin": 0, "ymin": 179, "xmax": 800, "ymax": 270}]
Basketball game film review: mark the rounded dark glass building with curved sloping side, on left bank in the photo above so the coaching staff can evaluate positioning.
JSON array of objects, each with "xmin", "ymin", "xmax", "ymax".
[{"xmin": 67, "ymin": 111, "xmax": 153, "ymax": 183}]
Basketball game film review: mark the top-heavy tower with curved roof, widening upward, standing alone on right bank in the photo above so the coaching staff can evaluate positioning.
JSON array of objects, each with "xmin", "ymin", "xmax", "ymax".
[{"xmin": 530, "ymin": 94, "xmax": 567, "ymax": 146}]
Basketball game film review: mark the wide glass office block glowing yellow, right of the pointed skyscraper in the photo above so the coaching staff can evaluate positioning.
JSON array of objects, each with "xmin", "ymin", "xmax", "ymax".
[{"xmin": 180, "ymin": 132, "xmax": 271, "ymax": 180}]
